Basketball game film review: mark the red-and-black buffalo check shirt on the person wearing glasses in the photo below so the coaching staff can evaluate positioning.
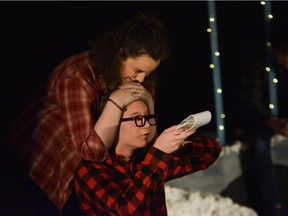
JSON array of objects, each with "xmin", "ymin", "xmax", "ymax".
[{"xmin": 74, "ymin": 137, "xmax": 221, "ymax": 216}]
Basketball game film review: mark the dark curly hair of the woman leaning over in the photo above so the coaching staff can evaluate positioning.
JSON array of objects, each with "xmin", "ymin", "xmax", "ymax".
[{"xmin": 90, "ymin": 13, "xmax": 170, "ymax": 91}]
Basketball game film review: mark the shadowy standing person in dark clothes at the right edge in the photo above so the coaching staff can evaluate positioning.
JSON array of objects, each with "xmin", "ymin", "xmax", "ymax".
[{"xmin": 241, "ymin": 19, "xmax": 288, "ymax": 216}]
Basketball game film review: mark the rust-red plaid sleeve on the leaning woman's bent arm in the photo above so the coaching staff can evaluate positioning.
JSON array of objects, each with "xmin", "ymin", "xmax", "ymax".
[{"xmin": 57, "ymin": 77, "xmax": 108, "ymax": 161}]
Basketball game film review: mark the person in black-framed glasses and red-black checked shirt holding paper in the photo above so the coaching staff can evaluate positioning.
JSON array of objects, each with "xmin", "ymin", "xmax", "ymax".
[{"xmin": 74, "ymin": 99, "xmax": 221, "ymax": 216}]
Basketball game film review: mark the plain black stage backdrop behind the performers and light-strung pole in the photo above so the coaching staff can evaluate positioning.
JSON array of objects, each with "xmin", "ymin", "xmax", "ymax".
[{"xmin": 0, "ymin": 1, "xmax": 288, "ymax": 145}]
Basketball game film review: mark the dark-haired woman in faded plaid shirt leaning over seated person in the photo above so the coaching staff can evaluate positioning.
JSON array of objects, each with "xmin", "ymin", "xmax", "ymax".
[{"xmin": 8, "ymin": 13, "xmax": 169, "ymax": 216}]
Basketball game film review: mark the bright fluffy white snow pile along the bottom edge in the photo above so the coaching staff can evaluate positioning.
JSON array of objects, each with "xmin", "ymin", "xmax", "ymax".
[{"xmin": 165, "ymin": 185, "xmax": 257, "ymax": 216}]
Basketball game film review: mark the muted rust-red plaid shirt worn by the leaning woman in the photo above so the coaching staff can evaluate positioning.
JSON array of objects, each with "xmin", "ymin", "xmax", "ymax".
[{"xmin": 9, "ymin": 52, "xmax": 118, "ymax": 208}]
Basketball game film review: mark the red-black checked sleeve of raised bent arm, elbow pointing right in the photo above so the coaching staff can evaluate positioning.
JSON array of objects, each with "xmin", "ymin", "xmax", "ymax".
[{"xmin": 165, "ymin": 136, "xmax": 222, "ymax": 182}]
